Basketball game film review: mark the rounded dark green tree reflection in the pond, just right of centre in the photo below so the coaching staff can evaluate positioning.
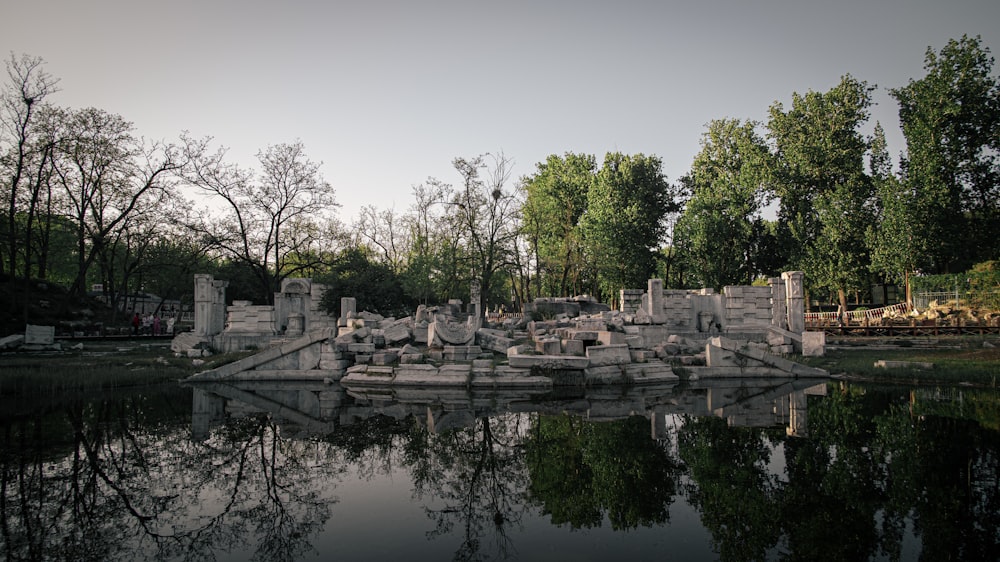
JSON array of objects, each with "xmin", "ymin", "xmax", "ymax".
[{"xmin": 525, "ymin": 415, "xmax": 679, "ymax": 530}]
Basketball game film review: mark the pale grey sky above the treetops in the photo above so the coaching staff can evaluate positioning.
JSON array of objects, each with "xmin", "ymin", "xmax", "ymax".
[{"xmin": 0, "ymin": 0, "xmax": 1000, "ymax": 222}]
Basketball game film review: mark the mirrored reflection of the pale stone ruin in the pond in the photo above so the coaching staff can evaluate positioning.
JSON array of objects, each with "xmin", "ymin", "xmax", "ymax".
[{"xmin": 191, "ymin": 378, "xmax": 827, "ymax": 440}]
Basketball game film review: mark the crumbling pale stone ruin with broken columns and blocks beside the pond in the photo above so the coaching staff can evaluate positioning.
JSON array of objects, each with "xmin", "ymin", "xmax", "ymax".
[{"xmin": 173, "ymin": 272, "xmax": 827, "ymax": 388}]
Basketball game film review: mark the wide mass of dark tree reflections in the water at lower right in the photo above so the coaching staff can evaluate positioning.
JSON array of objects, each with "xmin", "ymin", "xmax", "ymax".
[{"xmin": 678, "ymin": 387, "xmax": 1000, "ymax": 560}]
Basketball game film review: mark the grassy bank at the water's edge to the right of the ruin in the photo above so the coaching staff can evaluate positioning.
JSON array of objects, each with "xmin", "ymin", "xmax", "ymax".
[{"xmin": 801, "ymin": 336, "xmax": 1000, "ymax": 388}]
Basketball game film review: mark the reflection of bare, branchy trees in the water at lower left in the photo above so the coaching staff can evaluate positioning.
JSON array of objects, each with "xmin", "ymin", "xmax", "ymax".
[{"xmin": 0, "ymin": 390, "xmax": 344, "ymax": 560}]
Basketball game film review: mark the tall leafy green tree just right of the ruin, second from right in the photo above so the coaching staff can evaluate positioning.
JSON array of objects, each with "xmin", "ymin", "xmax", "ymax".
[{"xmin": 768, "ymin": 75, "xmax": 874, "ymax": 309}]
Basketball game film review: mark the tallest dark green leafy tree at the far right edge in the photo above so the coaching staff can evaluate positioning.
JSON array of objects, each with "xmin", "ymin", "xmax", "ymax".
[{"xmin": 890, "ymin": 35, "xmax": 1000, "ymax": 273}]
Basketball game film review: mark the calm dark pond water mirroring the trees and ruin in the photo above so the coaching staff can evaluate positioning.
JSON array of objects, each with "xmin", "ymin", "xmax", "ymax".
[{"xmin": 0, "ymin": 374, "xmax": 1000, "ymax": 560}]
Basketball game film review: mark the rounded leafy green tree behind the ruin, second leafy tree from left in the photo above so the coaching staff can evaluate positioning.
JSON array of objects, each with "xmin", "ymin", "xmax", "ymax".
[{"xmin": 581, "ymin": 153, "xmax": 680, "ymax": 300}]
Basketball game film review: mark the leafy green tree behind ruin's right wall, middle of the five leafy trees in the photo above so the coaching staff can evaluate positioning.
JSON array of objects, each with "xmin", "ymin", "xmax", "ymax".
[{"xmin": 674, "ymin": 119, "xmax": 773, "ymax": 290}]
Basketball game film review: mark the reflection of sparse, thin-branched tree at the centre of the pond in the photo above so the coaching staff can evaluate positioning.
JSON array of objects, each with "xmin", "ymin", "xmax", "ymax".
[{"xmin": 404, "ymin": 414, "xmax": 526, "ymax": 560}]
